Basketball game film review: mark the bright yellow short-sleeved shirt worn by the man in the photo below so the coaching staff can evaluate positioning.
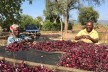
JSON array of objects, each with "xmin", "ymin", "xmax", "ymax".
[{"xmin": 76, "ymin": 29, "xmax": 99, "ymax": 43}]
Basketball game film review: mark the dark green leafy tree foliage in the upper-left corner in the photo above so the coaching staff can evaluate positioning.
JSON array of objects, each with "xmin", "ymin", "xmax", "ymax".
[{"xmin": 0, "ymin": 0, "xmax": 24, "ymax": 27}]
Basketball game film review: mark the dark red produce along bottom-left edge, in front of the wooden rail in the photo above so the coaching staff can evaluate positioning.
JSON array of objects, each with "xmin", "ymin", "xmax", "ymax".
[{"xmin": 0, "ymin": 60, "xmax": 55, "ymax": 72}]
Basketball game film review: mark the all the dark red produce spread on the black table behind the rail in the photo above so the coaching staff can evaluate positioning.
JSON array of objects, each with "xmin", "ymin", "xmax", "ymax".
[{"xmin": 6, "ymin": 41, "xmax": 108, "ymax": 72}]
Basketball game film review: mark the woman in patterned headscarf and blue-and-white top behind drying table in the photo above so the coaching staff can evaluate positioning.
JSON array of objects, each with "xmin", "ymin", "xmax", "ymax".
[{"xmin": 7, "ymin": 24, "xmax": 32, "ymax": 44}]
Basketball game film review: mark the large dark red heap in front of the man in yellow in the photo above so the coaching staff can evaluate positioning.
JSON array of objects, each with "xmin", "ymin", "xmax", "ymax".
[{"xmin": 58, "ymin": 42, "xmax": 108, "ymax": 72}]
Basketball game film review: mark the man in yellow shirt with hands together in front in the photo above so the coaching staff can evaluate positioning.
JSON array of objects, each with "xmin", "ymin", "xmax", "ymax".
[{"xmin": 75, "ymin": 21, "xmax": 99, "ymax": 43}]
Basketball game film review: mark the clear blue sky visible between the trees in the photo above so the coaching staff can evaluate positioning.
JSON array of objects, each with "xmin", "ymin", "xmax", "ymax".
[{"xmin": 22, "ymin": 0, "xmax": 108, "ymax": 20}]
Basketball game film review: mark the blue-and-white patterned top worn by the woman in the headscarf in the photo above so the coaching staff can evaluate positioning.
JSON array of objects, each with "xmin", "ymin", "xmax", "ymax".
[{"xmin": 7, "ymin": 35, "xmax": 31, "ymax": 44}]
